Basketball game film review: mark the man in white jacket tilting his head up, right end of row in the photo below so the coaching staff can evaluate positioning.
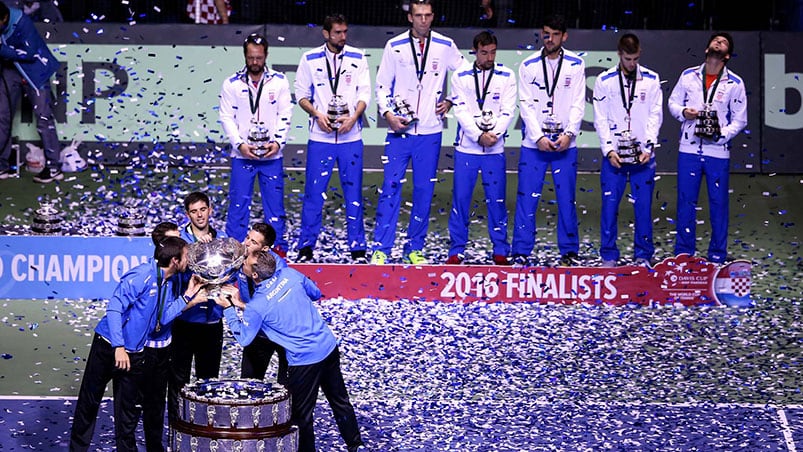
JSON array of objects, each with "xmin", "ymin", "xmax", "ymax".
[{"xmin": 669, "ymin": 32, "xmax": 747, "ymax": 264}]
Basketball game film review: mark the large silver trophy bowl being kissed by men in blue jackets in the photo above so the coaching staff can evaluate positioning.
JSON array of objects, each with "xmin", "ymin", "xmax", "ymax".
[{"xmin": 187, "ymin": 237, "xmax": 246, "ymax": 299}]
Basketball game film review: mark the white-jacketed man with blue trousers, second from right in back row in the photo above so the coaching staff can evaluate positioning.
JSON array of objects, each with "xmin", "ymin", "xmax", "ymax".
[{"xmin": 594, "ymin": 33, "xmax": 664, "ymax": 267}]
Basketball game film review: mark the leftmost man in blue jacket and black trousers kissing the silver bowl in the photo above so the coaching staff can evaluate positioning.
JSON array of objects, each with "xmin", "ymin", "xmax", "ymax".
[{"xmin": 70, "ymin": 237, "xmax": 205, "ymax": 451}]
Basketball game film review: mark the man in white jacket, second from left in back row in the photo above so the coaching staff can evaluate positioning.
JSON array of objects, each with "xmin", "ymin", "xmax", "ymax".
[{"xmin": 295, "ymin": 14, "xmax": 371, "ymax": 262}]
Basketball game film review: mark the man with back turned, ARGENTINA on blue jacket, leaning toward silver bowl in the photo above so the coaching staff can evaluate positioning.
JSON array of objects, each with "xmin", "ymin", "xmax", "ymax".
[{"xmin": 216, "ymin": 251, "xmax": 362, "ymax": 452}]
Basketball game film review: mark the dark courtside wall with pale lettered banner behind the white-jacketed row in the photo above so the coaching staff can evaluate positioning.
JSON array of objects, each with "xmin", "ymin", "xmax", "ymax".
[{"xmin": 15, "ymin": 23, "xmax": 803, "ymax": 174}]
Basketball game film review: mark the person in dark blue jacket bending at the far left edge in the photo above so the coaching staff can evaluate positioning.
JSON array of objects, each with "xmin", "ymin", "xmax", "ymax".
[{"xmin": 0, "ymin": 2, "xmax": 64, "ymax": 183}]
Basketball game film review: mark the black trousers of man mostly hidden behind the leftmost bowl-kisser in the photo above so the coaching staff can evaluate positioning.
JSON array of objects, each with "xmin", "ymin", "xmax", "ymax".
[{"xmin": 142, "ymin": 345, "xmax": 172, "ymax": 452}]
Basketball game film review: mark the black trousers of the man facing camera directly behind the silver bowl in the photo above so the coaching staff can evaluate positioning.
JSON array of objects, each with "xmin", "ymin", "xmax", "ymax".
[{"xmin": 167, "ymin": 319, "xmax": 223, "ymax": 423}]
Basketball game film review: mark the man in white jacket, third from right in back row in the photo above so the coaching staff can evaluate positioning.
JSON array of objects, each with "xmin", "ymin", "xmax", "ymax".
[{"xmin": 512, "ymin": 15, "xmax": 586, "ymax": 266}]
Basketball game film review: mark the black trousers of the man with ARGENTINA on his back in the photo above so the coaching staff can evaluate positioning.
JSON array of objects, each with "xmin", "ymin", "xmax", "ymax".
[{"xmin": 288, "ymin": 347, "xmax": 362, "ymax": 452}]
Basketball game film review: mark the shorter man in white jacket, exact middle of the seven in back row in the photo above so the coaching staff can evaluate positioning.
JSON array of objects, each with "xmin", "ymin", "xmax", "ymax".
[{"xmin": 446, "ymin": 31, "xmax": 518, "ymax": 265}]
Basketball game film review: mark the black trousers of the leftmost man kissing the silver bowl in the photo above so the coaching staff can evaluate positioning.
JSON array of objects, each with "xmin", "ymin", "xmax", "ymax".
[{"xmin": 70, "ymin": 334, "xmax": 146, "ymax": 452}]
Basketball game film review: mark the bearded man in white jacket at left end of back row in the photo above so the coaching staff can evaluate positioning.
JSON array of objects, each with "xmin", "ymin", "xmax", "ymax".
[{"xmin": 220, "ymin": 33, "xmax": 293, "ymax": 256}]
